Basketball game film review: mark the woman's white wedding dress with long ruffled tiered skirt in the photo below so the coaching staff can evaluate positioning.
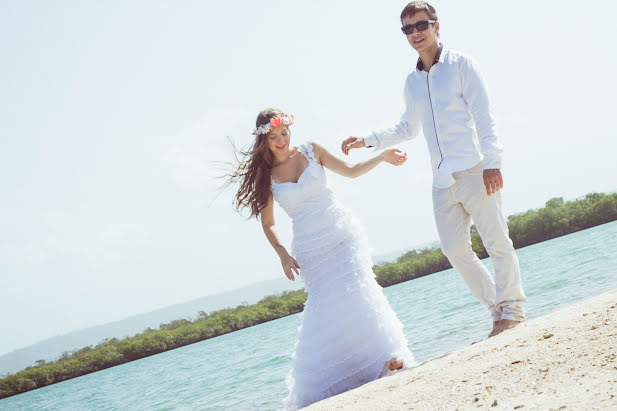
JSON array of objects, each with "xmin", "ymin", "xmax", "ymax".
[{"xmin": 272, "ymin": 143, "xmax": 415, "ymax": 410}]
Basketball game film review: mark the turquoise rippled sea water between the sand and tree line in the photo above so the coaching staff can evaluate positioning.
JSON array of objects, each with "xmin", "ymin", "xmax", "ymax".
[{"xmin": 0, "ymin": 222, "xmax": 617, "ymax": 410}]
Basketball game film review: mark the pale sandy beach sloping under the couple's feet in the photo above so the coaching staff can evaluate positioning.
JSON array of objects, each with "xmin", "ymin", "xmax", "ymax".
[{"xmin": 306, "ymin": 290, "xmax": 617, "ymax": 410}]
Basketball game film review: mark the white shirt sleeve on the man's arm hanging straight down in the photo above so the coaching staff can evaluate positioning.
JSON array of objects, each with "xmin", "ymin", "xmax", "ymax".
[{"xmin": 461, "ymin": 56, "xmax": 503, "ymax": 169}]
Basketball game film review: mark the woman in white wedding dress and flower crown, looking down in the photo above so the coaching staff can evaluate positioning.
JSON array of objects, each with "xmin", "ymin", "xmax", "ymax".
[{"xmin": 229, "ymin": 109, "xmax": 415, "ymax": 409}]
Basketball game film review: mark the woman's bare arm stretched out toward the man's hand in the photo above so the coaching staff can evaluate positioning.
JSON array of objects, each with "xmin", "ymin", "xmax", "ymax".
[{"xmin": 312, "ymin": 143, "xmax": 407, "ymax": 178}]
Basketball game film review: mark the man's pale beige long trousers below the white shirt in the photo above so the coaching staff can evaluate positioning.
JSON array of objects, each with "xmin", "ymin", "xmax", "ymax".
[{"xmin": 433, "ymin": 163, "xmax": 527, "ymax": 321}]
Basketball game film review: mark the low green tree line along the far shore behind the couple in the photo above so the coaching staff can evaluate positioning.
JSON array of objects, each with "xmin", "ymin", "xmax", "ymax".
[{"xmin": 0, "ymin": 193, "xmax": 617, "ymax": 398}]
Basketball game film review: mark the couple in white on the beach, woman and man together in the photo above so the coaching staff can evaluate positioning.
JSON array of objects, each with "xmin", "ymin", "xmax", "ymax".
[{"xmin": 230, "ymin": 1, "xmax": 526, "ymax": 409}]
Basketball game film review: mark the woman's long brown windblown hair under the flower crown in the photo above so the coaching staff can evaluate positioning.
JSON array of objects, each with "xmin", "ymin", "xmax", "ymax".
[{"xmin": 227, "ymin": 108, "xmax": 285, "ymax": 218}]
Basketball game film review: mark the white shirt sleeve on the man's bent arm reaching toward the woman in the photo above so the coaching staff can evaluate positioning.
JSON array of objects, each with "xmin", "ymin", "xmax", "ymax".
[{"xmin": 364, "ymin": 78, "xmax": 422, "ymax": 150}]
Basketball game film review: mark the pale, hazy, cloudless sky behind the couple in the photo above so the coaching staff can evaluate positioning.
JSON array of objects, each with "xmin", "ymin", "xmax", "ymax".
[{"xmin": 0, "ymin": 0, "xmax": 617, "ymax": 354}]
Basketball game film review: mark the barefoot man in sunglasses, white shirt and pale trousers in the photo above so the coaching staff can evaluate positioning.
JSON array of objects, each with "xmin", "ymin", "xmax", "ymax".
[{"xmin": 342, "ymin": 1, "xmax": 526, "ymax": 337}]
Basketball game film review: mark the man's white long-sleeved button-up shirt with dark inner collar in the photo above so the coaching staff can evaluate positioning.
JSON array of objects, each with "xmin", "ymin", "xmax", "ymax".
[{"xmin": 364, "ymin": 46, "xmax": 502, "ymax": 188}]
